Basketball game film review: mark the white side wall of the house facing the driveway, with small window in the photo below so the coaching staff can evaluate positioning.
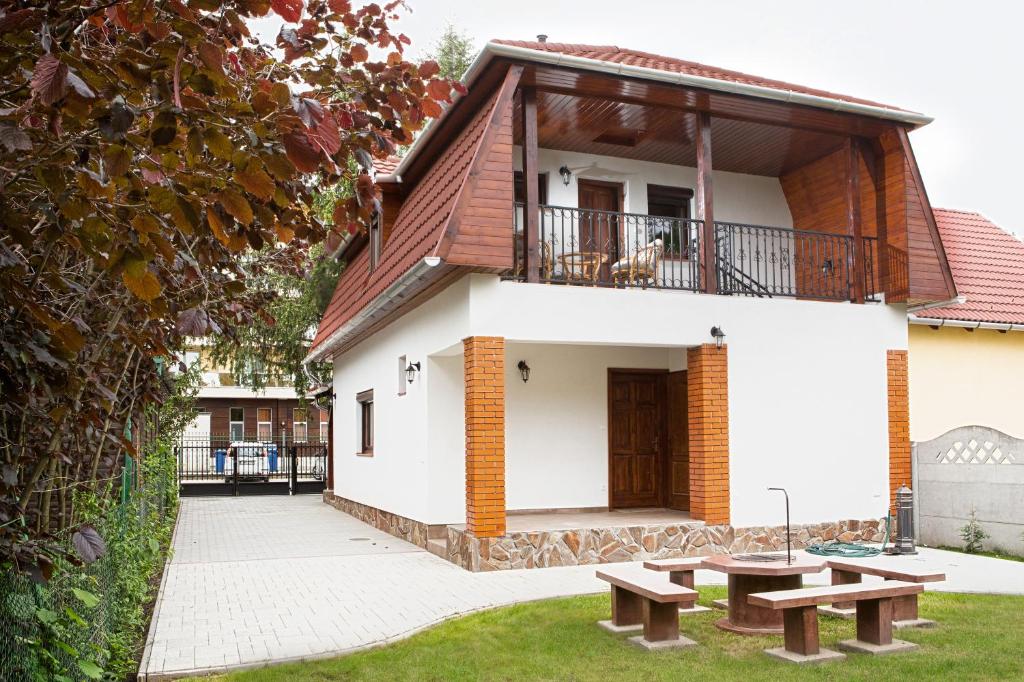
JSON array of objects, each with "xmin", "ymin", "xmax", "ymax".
[{"xmin": 334, "ymin": 280, "xmax": 470, "ymax": 521}]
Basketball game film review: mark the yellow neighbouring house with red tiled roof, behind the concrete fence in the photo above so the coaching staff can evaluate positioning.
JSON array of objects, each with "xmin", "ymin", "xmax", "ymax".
[{"xmin": 908, "ymin": 209, "xmax": 1024, "ymax": 441}]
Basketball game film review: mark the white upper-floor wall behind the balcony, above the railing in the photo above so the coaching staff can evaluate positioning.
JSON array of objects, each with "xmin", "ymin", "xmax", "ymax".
[{"xmin": 513, "ymin": 147, "xmax": 793, "ymax": 227}]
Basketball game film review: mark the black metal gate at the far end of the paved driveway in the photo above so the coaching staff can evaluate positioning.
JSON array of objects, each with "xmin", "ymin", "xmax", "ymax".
[{"xmin": 175, "ymin": 433, "xmax": 327, "ymax": 497}]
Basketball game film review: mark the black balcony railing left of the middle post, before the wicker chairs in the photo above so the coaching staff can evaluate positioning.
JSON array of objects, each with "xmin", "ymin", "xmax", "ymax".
[{"xmin": 510, "ymin": 203, "xmax": 702, "ymax": 291}]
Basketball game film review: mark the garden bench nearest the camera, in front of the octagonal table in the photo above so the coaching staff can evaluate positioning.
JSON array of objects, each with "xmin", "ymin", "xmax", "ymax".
[{"xmin": 748, "ymin": 581, "xmax": 925, "ymax": 663}]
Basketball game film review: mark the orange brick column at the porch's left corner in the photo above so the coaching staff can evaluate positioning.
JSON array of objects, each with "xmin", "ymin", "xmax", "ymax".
[{"xmin": 462, "ymin": 336, "xmax": 505, "ymax": 538}]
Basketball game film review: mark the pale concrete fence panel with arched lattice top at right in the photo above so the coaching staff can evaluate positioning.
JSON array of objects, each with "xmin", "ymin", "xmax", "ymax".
[{"xmin": 913, "ymin": 426, "xmax": 1024, "ymax": 554}]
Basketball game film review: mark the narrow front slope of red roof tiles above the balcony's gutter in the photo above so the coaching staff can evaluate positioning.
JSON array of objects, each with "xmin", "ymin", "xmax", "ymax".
[{"xmin": 492, "ymin": 40, "xmax": 906, "ymax": 112}]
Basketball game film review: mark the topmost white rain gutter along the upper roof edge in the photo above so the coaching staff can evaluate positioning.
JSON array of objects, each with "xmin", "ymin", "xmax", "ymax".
[{"xmin": 379, "ymin": 43, "xmax": 935, "ymax": 182}]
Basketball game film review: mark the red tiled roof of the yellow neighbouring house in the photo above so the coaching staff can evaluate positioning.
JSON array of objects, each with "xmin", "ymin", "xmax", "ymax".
[{"xmin": 916, "ymin": 208, "xmax": 1024, "ymax": 325}]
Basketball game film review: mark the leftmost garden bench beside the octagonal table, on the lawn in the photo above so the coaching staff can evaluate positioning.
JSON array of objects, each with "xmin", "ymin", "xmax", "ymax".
[{"xmin": 597, "ymin": 563, "xmax": 697, "ymax": 649}]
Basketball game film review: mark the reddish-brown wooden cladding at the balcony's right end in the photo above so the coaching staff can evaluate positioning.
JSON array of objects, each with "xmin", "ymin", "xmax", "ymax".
[{"xmin": 779, "ymin": 131, "xmax": 955, "ymax": 304}]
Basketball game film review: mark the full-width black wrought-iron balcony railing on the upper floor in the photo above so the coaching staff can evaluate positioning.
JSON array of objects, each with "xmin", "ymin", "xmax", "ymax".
[{"xmin": 505, "ymin": 203, "xmax": 881, "ymax": 301}]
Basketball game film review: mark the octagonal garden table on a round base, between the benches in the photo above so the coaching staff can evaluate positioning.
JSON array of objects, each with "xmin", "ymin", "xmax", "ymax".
[{"xmin": 700, "ymin": 554, "xmax": 825, "ymax": 635}]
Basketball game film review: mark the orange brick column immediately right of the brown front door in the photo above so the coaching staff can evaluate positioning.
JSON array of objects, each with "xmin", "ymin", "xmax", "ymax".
[{"xmin": 686, "ymin": 343, "xmax": 729, "ymax": 525}]
